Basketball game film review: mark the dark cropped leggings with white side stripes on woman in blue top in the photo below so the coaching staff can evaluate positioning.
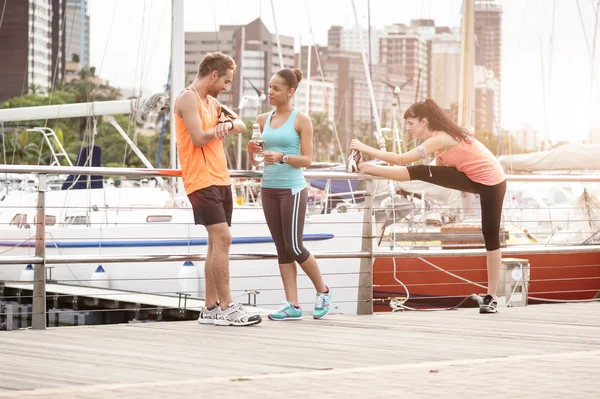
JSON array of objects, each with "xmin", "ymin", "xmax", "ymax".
[{"xmin": 260, "ymin": 187, "xmax": 310, "ymax": 264}]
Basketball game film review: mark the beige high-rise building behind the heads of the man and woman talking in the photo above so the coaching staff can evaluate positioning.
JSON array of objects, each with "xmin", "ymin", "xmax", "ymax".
[{"xmin": 185, "ymin": 18, "xmax": 295, "ymax": 119}]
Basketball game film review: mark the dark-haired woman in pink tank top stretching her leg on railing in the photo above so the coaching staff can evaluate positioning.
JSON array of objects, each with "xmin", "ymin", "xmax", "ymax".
[{"xmin": 350, "ymin": 99, "xmax": 506, "ymax": 313}]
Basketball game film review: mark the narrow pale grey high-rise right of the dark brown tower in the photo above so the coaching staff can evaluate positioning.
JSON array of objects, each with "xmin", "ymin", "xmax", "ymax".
[{"xmin": 63, "ymin": 0, "xmax": 90, "ymax": 68}]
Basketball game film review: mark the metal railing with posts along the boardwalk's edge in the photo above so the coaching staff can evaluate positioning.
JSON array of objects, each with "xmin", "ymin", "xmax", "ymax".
[{"xmin": 0, "ymin": 165, "xmax": 600, "ymax": 329}]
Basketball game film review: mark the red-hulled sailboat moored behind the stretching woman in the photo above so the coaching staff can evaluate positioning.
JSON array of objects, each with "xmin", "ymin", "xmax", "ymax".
[{"xmin": 373, "ymin": 0, "xmax": 600, "ymax": 311}]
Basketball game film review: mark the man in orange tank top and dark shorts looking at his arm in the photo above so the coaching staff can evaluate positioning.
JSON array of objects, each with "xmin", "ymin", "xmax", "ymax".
[{"xmin": 175, "ymin": 51, "xmax": 262, "ymax": 326}]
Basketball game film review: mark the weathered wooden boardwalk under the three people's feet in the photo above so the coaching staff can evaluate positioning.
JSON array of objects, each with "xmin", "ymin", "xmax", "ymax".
[{"xmin": 0, "ymin": 303, "xmax": 600, "ymax": 398}]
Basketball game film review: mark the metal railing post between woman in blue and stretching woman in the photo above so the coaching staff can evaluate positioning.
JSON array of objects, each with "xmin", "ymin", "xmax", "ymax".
[{"xmin": 356, "ymin": 179, "xmax": 375, "ymax": 315}]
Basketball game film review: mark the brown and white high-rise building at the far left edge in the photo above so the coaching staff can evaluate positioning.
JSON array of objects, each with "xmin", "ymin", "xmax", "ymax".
[{"xmin": 0, "ymin": 0, "xmax": 65, "ymax": 101}]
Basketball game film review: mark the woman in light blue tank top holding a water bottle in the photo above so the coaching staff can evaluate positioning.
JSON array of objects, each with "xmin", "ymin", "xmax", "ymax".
[{"xmin": 247, "ymin": 68, "xmax": 331, "ymax": 320}]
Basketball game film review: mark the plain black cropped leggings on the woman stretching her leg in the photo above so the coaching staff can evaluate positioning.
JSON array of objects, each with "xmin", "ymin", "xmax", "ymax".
[{"xmin": 407, "ymin": 165, "xmax": 506, "ymax": 251}]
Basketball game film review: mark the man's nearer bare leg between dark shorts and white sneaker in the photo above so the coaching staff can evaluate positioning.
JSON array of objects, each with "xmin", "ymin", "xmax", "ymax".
[{"xmin": 205, "ymin": 223, "xmax": 233, "ymax": 310}]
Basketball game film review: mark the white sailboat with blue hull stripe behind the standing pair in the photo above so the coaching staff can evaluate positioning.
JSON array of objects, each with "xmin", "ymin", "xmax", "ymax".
[{"xmin": 0, "ymin": 0, "xmax": 362, "ymax": 313}]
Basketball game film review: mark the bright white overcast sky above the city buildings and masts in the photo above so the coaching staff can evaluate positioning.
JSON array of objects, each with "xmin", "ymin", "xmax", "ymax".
[{"xmin": 89, "ymin": 0, "xmax": 600, "ymax": 141}]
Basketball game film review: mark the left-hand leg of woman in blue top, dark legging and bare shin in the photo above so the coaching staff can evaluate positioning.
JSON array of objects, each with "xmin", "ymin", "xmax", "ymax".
[{"xmin": 261, "ymin": 188, "xmax": 298, "ymax": 306}]
